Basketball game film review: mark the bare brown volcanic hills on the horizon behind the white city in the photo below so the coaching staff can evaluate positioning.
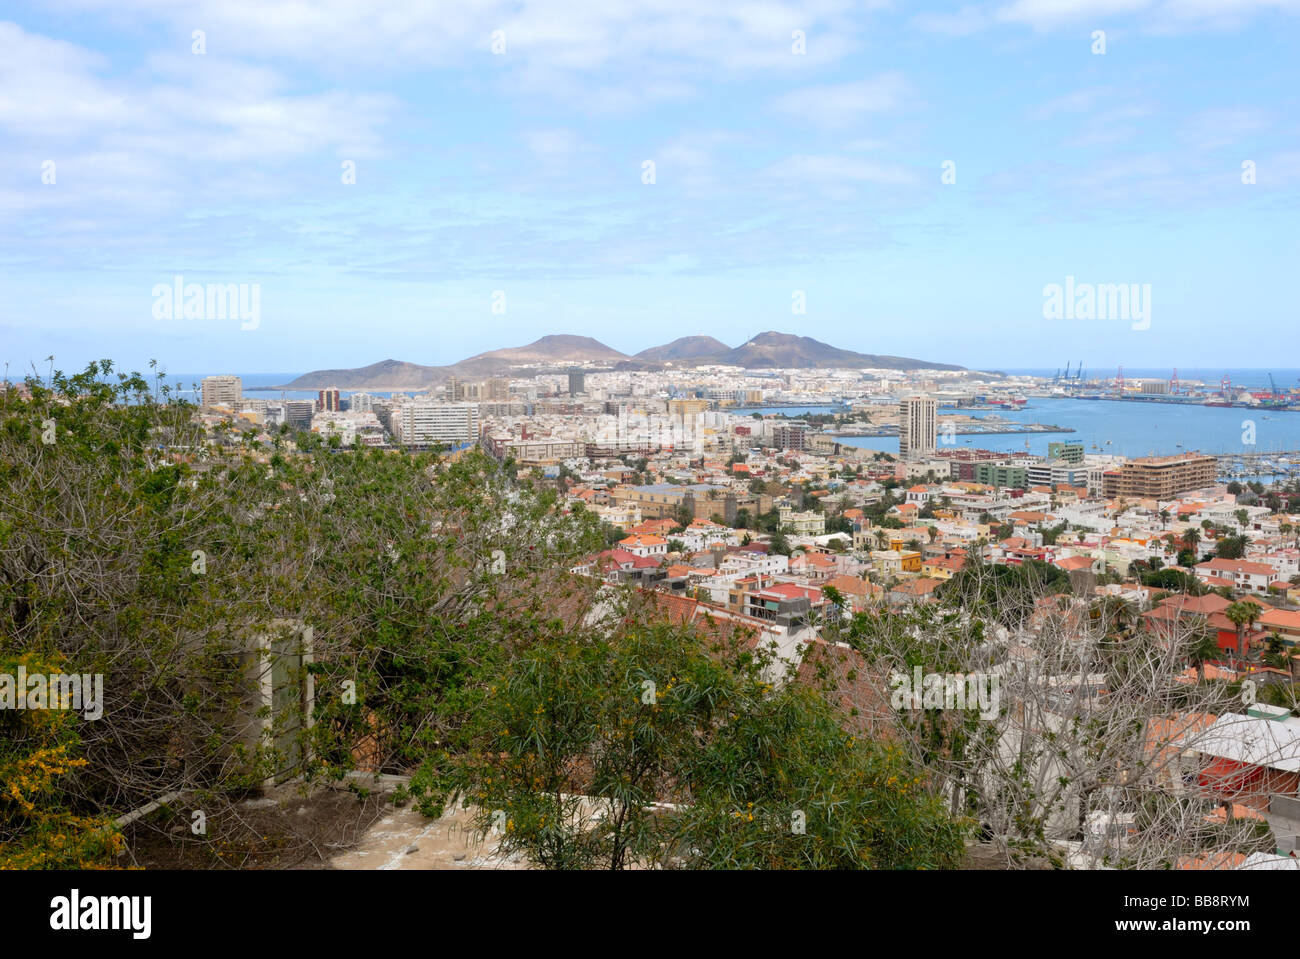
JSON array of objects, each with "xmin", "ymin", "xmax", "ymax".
[{"xmin": 281, "ymin": 331, "xmax": 965, "ymax": 390}]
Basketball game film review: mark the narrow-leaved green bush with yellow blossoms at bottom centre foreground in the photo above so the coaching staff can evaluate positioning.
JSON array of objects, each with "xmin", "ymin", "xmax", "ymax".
[{"xmin": 415, "ymin": 589, "xmax": 966, "ymax": 869}]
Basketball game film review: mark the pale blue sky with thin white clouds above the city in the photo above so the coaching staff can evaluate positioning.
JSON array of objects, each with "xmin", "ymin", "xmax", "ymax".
[{"xmin": 0, "ymin": 0, "xmax": 1300, "ymax": 376}]
